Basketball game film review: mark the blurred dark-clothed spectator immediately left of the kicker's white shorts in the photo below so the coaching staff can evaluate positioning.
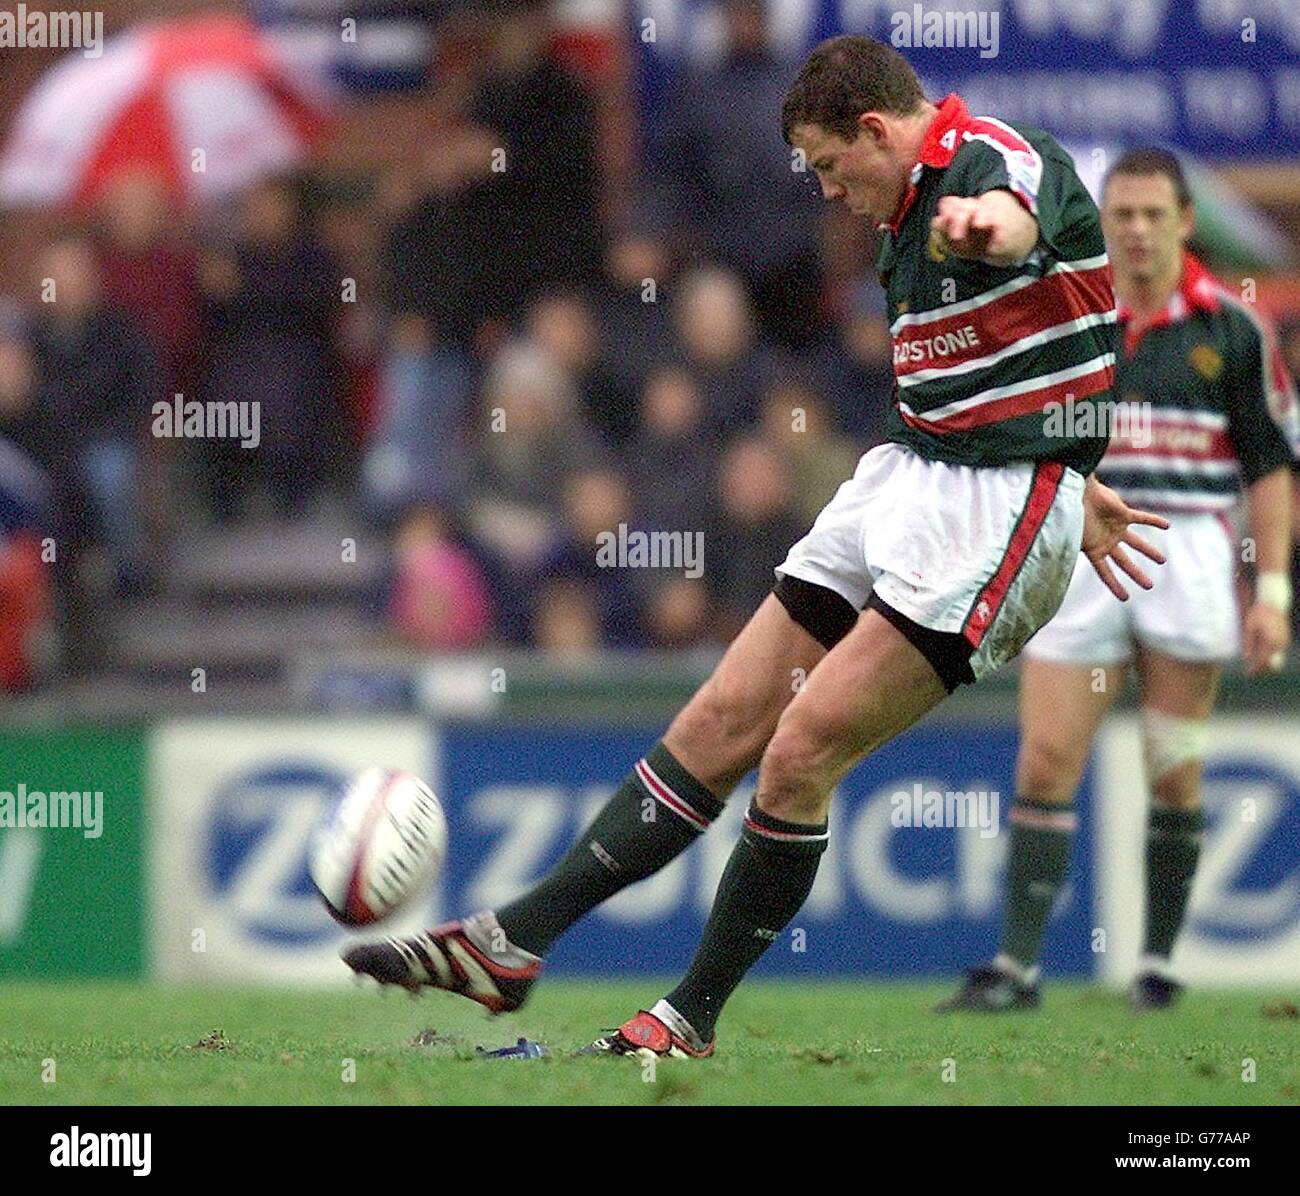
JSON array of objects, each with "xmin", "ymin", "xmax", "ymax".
[{"xmin": 705, "ymin": 437, "xmax": 807, "ymax": 640}]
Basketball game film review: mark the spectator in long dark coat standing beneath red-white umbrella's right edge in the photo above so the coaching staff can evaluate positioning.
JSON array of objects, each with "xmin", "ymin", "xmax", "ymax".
[{"xmin": 202, "ymin": 179, "xmax": 342, "ymax": 520}]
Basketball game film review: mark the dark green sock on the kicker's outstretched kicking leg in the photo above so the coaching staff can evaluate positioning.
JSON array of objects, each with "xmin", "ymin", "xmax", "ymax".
[{"xmin": 497, "ymin": 744, "xmax": 723, "ymax": 956}]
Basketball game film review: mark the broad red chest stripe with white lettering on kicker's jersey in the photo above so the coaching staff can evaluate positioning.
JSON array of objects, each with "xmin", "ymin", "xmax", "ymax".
[{"xmin": 894, "ymin": 265, "xmax": 1115, "ymax": 377}]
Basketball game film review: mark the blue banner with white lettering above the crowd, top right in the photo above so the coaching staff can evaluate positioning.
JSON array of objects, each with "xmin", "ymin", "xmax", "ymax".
[{"xmin": 632, "ymin": 0, "xmax": 1300, "ymax": 157}]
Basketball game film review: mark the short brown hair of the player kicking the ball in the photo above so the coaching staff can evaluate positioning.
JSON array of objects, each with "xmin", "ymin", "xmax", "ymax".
[{"xmin": 781, "ymin": 36, "xmax": 926, "ymax": 143}]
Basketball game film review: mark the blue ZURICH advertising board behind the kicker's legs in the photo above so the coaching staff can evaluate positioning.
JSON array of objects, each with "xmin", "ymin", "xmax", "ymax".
[{"xmin": 434, "ymin": 723, "xmax": 1096, "ymax": 978}]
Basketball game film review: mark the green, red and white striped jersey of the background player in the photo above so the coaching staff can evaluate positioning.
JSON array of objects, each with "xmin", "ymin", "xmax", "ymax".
[{"xmin": 1097, "ymin": 252, "xmax": 1300, "ymax": 511}]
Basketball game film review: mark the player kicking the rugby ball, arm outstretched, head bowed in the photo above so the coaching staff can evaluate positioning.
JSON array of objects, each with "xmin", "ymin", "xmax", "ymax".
[{"xmin": 345, "ymin": 36, "xmax": 1165, "ymax": 1056}]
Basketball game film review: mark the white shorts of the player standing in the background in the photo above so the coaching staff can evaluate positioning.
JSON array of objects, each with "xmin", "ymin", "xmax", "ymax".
[{"xmin": 1024, "ymin": 512, "xmax": 1240, "ymax": 664}]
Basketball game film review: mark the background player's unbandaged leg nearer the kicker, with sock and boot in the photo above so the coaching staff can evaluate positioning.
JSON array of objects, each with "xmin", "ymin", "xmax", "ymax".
[{"xmin": 939, "ymin": 655, "xmax": 1126, "ymax": 1013}]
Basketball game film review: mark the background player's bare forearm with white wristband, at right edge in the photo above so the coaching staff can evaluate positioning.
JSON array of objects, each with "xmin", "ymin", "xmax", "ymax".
[{"xmin": 1242, "ymin": 468, "xmax": 1291, "ymax": 677}]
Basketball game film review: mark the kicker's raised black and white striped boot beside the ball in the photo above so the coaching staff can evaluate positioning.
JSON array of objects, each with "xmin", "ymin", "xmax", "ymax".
[{"xmin": 343, "ymin": 914, "xmax": 542, "ymax": 1013}]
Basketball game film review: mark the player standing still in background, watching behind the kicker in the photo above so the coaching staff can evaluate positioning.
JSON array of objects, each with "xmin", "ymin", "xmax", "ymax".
[{"xmin": 940, "ymin": 150, "xmax": 1297, "ymax": 1011}]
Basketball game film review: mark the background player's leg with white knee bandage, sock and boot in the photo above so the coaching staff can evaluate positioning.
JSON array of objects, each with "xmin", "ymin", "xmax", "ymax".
[{"xmin": 1132, "ymin": 646, "xmax": 1222, "ymax": 1009}]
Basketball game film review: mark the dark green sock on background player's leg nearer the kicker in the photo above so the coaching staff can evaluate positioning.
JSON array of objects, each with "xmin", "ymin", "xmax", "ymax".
[{"xmin": 998, "ymin": 797, "xmax": 1078, "ymax": 969}]
